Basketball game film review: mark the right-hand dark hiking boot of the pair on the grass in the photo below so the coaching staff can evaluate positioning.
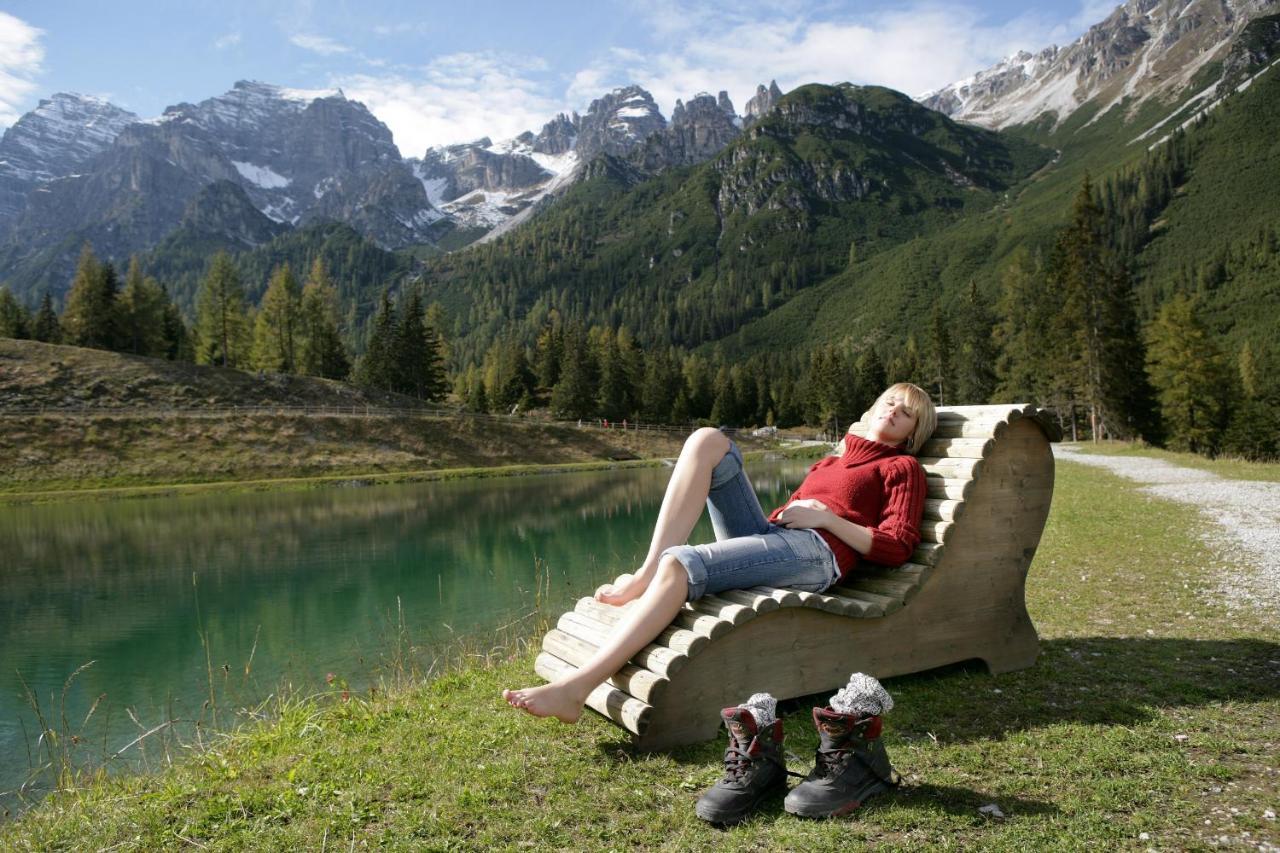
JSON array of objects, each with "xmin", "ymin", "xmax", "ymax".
[{"xmin": 782, "ymin": 708, "xmax": 899, "ymax": 817}]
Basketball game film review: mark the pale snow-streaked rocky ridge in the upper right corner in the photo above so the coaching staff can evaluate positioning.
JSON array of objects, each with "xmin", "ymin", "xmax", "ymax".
[{"xmin": 918, "ymin": 0, "xmax": 1280, "ymax": 128}]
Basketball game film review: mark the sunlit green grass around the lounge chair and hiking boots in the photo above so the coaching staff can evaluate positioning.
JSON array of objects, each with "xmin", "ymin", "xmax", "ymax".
[{"xmin": 0, "ymin": 462, "xmax": 1280, "ymax": 850}]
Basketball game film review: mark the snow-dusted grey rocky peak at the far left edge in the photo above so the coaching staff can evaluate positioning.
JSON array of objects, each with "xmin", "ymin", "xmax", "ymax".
[{"xmin": 0, "ymin": 92, "xmax": 138, "ymax": 232}]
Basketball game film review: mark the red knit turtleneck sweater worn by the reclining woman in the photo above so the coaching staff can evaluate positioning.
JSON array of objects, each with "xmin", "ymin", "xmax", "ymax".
[{"xmin": 769, "ymin": 434, "xmax": 928, "ymax": 576}]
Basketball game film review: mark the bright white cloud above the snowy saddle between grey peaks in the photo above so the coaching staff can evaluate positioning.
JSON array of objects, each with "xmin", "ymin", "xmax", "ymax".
[{"xmin": 333, "ymin": 53, "xmax": 564, "ymax": 156}]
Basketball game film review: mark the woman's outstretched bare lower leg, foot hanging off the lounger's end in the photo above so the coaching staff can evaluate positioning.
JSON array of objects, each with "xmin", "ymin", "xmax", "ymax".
[{"xmin": 502, "ymin": 556, "xmax": 689, "ymax": 722}]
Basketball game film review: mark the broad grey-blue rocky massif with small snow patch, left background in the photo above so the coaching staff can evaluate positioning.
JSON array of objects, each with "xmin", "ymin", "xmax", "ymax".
[{"xmin": 8, "ymin": 82, "xmax": 442, "ymax": 270}]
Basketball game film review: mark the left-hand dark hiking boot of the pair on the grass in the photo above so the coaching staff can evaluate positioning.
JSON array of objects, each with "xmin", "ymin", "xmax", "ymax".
[{"xmin": 694, "ymin": 707, "xmax": 787, "ymax": 825}]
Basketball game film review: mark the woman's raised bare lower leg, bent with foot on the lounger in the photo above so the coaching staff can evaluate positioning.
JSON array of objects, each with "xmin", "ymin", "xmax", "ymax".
[{"xmin": 595, "ymin": 427, "xmax": 730, "ymax": 604}]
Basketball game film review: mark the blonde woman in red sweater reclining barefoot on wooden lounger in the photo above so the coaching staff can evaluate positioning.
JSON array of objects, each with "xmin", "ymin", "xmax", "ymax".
[{"xmin": 502, "ymin": 382, "xmax": 937, "ymax": 722}]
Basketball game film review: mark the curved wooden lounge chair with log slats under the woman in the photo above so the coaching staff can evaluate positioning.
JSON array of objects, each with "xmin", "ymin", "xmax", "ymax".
[{"xmin": 535, "ymin": 405, "xmax": 1061, "ymax": 749}]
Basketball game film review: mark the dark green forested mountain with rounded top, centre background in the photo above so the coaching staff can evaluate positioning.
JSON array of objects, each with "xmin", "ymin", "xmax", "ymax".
[{"xmin": 422, "ymin": 85, "xmax": 1051, "ymax": 364}]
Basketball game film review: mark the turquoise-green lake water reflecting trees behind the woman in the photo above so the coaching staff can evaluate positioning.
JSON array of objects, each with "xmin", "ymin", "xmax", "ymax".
[{"xmin": 0, "ymin": 462, "xmax": 806, "ymax": 807}]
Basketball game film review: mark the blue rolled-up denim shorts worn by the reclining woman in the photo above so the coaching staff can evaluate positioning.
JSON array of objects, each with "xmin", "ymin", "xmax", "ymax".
[{"xmin": 662, "ymin": 441, "xmax": 840, "ymax": 601}]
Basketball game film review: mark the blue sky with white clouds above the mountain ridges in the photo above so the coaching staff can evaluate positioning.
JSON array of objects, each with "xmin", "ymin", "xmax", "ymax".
[{"xmin": 0, "ymin": 0, "xmax": 1115, "ymax": 156}]
